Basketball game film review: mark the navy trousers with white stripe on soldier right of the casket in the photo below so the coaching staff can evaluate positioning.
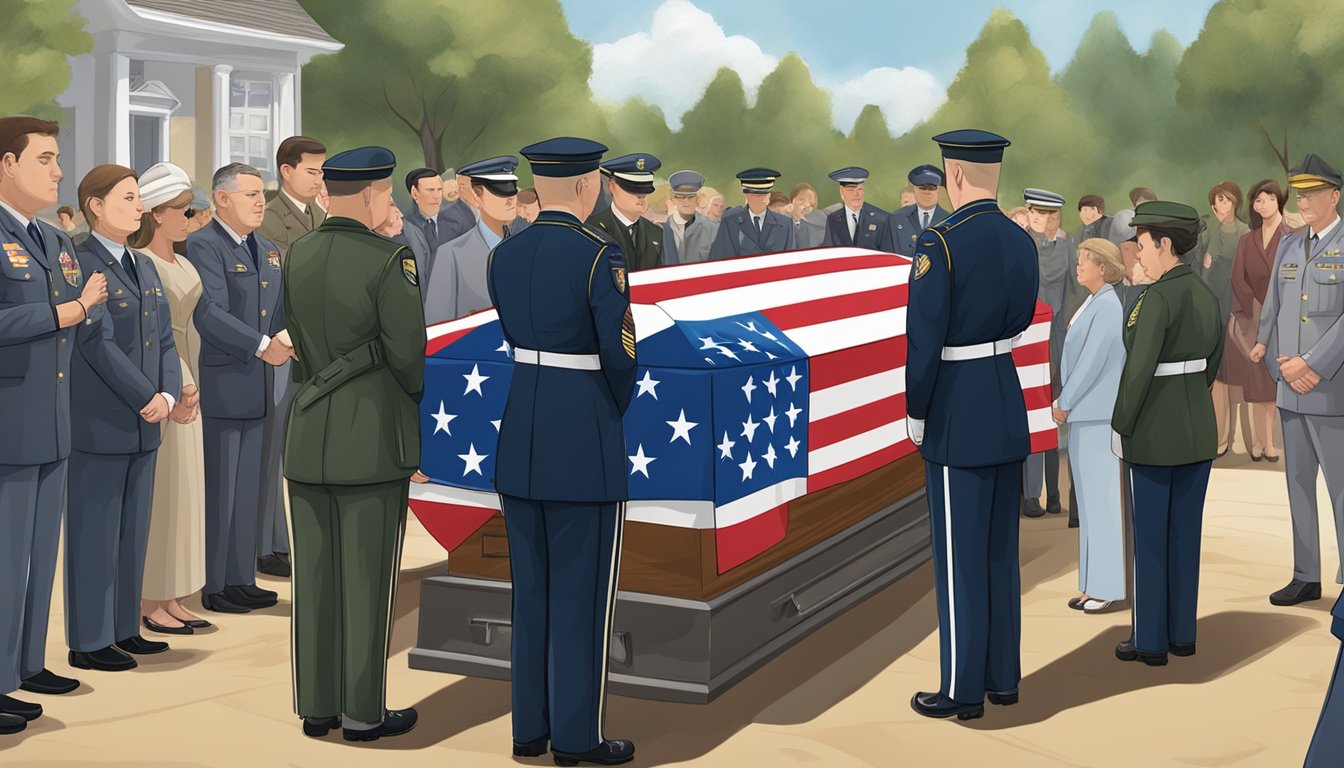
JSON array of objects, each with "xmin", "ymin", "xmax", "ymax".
[{"xmin": 925, "ymin": 461, "xmax": 1021, "ymax": 703}]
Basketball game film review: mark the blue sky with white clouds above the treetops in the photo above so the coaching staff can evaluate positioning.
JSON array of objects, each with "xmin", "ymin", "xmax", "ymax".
[{"xmin": 560, "ymin": 0, "xmax": 1214, "ymax": 135}]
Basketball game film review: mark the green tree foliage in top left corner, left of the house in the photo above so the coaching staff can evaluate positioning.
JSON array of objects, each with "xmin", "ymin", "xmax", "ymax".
[{"xmin": 0, "ymin": 0, "xmax": 93, "ymax": 118}]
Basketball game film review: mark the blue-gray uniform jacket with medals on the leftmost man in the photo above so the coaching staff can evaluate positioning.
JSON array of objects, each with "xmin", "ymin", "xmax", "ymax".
[{"xmin": 0, "ymin": 208, "xmax": 80, "ymax": 465}]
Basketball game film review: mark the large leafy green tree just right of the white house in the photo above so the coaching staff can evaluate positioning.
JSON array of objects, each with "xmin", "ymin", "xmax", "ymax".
[{"xmin": 301, "ymin": 0, "xmax": 605, "ymax": 171}]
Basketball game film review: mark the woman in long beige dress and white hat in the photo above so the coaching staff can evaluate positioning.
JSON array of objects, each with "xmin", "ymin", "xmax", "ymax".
[{"xmin": 128, "ymin": 163, "xmax": 210, "ymax": 635}]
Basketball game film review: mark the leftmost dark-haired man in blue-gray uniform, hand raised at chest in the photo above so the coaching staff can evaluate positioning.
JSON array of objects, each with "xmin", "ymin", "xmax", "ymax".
[{"xmin": 0, "ymin": 117, "xmax": 108, "ymax": 734}]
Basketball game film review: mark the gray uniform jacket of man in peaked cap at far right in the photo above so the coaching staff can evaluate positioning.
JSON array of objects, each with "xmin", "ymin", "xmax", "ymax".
[{"xmin": 1258, "ymin": 223, "xmax": 1344, "ymax": 416}]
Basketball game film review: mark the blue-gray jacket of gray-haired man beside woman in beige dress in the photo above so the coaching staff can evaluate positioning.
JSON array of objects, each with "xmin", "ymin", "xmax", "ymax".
[{"xmin": 187, "ymin": 221, "xmax": 285, "ymax": 418}]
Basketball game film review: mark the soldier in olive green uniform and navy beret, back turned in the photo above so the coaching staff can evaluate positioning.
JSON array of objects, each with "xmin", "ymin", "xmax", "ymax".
[{"xmin": 285, "ymin": 147, "xmax": 425, "ymax": 741}]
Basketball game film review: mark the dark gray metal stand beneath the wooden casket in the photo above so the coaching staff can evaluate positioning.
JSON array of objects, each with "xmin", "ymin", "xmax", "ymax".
[{"xmin": 410, "ymin": 488, "xmax": 930, "ymax": 703}]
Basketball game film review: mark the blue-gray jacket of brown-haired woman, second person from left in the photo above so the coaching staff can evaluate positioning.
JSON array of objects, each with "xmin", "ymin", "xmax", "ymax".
[{"xmin": 70, "ymin": 237, "xmax": 181, "ymax": 453}]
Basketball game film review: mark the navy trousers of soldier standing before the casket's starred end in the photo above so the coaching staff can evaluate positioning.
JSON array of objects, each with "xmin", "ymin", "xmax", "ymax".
[{"xmin": 500, "ymin": 495, "xmax": 625, "ymax": 753}]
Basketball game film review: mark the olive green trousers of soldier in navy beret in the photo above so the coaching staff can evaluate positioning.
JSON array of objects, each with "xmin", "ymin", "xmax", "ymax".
[{"xmin": 289, "ymin": 480, "xmax": 410, "ymax": 725}]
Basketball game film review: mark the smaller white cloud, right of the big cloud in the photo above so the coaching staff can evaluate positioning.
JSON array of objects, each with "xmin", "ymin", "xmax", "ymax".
[{"xmin": 831, "ymin": 67, "xmax": 948, "ymax": 136}]
